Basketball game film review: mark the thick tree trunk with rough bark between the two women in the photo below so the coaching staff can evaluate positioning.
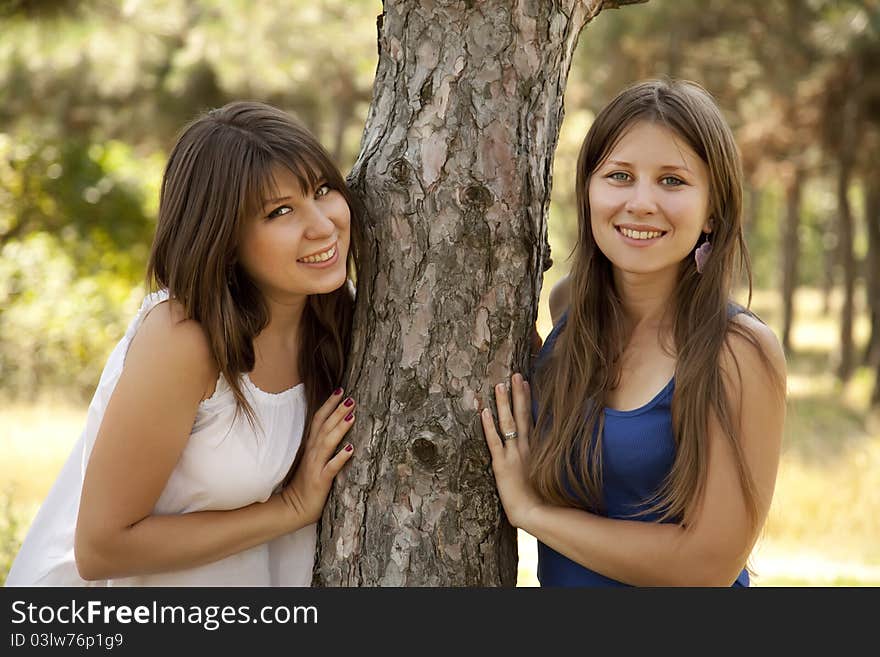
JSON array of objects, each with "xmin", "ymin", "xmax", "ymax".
[{"xmin": 314, "ymin": 0, "xmax": 638, "ymax": 586}]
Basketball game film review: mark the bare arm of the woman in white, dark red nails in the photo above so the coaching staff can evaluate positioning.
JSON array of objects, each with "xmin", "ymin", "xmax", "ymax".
[{"xmin": 75, "ymin": 303, "xmax": 351, "ymax": 579}]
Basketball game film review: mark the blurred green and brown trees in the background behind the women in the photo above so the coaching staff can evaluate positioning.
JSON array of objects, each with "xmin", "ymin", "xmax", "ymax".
[{"xmin": 0, "ymin": 0, "xmax": 880, "ymax": 404}]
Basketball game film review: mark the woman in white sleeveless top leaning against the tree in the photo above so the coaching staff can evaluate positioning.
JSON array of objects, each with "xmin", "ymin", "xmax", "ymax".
[{"xmin": 7, "ymin": 102, "xmax": 361, "ymax": 586}]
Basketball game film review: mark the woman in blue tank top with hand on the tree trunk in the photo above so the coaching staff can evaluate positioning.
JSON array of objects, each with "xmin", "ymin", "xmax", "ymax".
[{"xmin": 481, "ymin": 81, "xmax": 785, "ymax": 586}]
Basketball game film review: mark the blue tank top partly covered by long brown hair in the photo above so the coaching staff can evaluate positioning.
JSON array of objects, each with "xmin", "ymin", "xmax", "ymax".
[{"xmin": 532, "ymin": 307, "xmax": 749, "ymax": 586}]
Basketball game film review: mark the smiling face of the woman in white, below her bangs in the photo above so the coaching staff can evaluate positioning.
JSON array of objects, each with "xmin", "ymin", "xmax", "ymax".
[{"xmin": 238, "ymin": 166, "xmax": 351, "ymax": 301}]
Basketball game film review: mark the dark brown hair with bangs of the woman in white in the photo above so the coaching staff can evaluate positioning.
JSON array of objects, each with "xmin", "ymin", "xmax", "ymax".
[{"xmin": 147, "ymin": 101, "xmax": 362, "ymax": 435}]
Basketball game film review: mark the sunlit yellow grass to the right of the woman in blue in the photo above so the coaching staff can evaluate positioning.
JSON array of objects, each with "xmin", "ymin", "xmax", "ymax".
[{"xmin": 753, "ymin": 289, "xmax": 880, "ymax": 586}]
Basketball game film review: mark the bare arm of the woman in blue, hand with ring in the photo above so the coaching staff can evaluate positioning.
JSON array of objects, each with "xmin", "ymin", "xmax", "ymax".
[{"xmin": 483, "ymin": 319, "xmax": 785, "ymax": 586}]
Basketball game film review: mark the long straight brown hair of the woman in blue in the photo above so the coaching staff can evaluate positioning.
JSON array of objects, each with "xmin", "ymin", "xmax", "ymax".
[{"xmin": 530, "ymin": 80, "xmax": 781, "ymax": 527}]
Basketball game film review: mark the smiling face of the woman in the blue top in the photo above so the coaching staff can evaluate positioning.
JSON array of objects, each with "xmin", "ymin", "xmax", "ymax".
[{"xmin": 588, "ymin": 121, "xmax": 711, "ymax": 275}]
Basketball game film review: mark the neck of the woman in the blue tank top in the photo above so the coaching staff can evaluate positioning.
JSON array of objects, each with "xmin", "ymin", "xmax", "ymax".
[{"xmin": 614, "ymin": 267, "xmax": 678, "ymax": 330}]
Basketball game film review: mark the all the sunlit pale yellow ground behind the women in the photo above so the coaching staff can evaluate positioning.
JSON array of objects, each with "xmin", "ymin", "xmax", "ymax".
[{"xmin": 0, "ymin": 290, "xmax": 880, "ymax": 586}]
